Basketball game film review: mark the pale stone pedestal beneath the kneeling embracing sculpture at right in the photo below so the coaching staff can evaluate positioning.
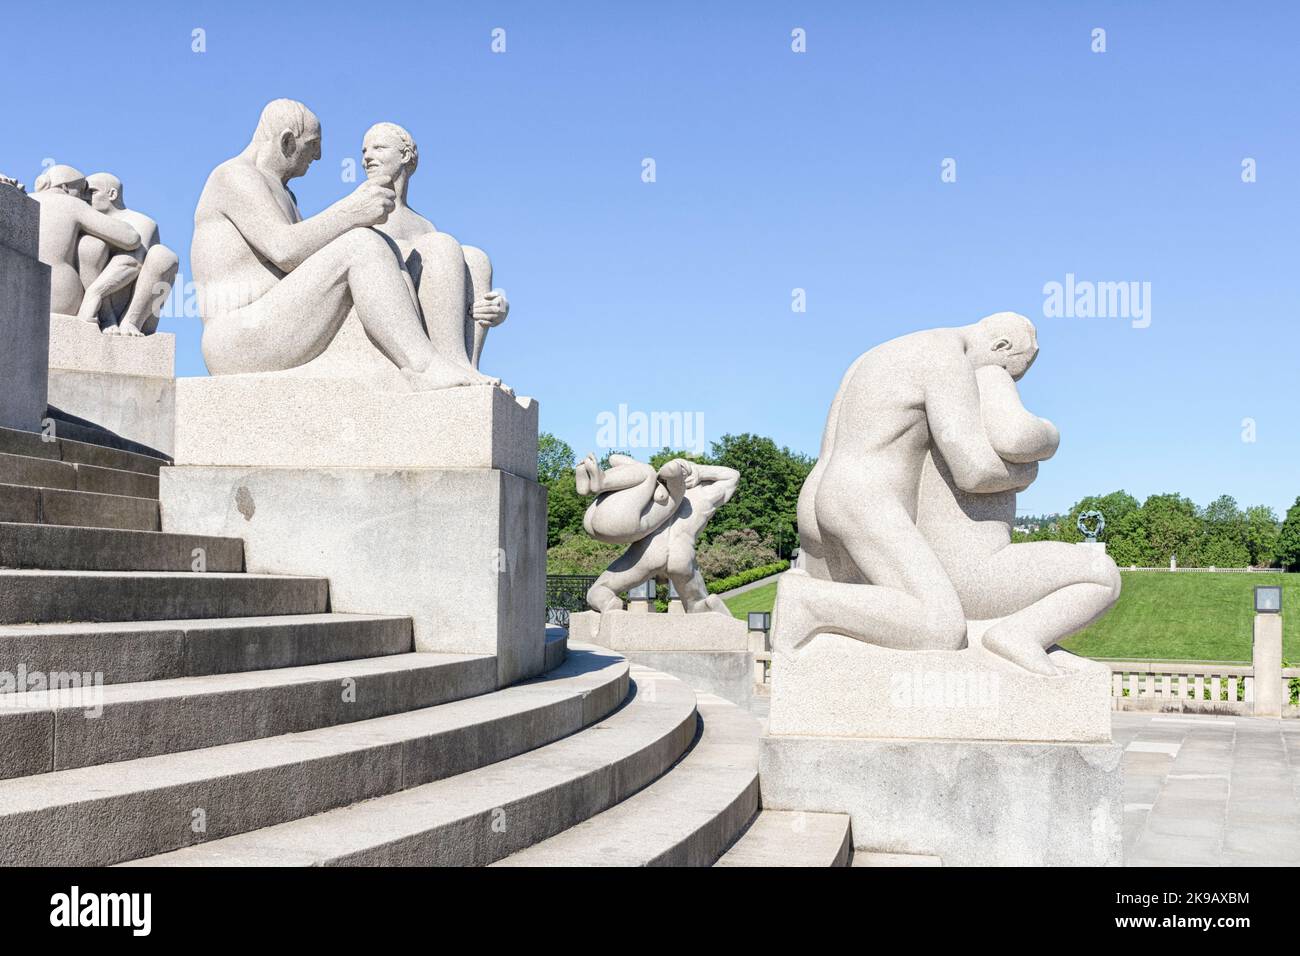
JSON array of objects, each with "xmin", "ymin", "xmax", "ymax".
[{"xmin": 761, "ymin": 622, "xmax": 1123, "ymax": 865}]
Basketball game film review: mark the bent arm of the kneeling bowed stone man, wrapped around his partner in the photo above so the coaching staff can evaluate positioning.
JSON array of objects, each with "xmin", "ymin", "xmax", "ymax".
[{"xmin": 926, "ymin": 351, "xmax": 1037, "ymax": 494}]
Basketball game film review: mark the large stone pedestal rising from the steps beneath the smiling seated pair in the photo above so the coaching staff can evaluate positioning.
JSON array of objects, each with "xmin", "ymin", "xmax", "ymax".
[{"xmin": 160, "ymin": 373, "xmax": 546, "ymax": 685}]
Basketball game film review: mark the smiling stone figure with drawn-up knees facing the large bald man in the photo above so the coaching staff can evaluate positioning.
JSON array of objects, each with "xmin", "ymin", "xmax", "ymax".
[{"xmin": 361, "ymin": 122, "xmax": 510, "ymax": 368}]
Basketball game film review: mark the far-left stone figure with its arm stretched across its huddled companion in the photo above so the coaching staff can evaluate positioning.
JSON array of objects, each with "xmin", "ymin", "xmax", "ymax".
[{"xmin": 31, "ymin": 165, "xmax": 140, "ymax": 315}]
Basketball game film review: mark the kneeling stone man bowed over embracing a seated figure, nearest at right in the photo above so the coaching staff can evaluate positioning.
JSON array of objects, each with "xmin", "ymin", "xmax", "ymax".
[{"xmin": 774, "ymin": 312, "xmax": 1119, "ymax": 675}]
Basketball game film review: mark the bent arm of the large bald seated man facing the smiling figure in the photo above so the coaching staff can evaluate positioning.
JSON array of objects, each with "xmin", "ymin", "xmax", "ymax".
[{"xmin": 209, "ymin": 168, "xmax": 358, "ymax": 272}]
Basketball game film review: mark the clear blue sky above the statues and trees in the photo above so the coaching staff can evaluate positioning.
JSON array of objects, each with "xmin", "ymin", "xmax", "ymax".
[{"xmin": 0, "ymin": 3, "xmax": 1300, "ymax": 512}]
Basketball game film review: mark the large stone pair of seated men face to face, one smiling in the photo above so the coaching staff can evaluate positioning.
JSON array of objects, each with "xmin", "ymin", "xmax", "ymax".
[{"xmin": 191, "ymin": 100, "xmax": 510, "ymax": 390}]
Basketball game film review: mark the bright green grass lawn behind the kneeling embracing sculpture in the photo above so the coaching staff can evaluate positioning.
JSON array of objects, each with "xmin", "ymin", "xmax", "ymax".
[{"xmin": 727, "ymin": 571, "xmax": 1300, "ymax": 662}]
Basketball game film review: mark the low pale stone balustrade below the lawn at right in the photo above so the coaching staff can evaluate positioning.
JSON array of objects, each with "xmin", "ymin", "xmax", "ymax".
[{"xmin": 1102, "ymin": 661, "xmax": 1300, "ymax": 717}]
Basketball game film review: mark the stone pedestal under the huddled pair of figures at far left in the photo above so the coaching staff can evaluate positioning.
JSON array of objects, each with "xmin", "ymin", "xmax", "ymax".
[{"xmin": 49, "ymin": 313, "xmax": 176, "ymax": 457}]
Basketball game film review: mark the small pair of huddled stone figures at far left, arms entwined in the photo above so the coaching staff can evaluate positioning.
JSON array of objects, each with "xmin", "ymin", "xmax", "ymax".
[{"xmin": 33, "ymin": 165, "xmax": 179, "ymax": 337}]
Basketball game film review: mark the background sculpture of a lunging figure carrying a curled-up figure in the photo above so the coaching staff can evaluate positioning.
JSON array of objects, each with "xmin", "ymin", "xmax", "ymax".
[{"xmin": 575, "ymin": 455, "xmax": 740, "ymax": 617}]
